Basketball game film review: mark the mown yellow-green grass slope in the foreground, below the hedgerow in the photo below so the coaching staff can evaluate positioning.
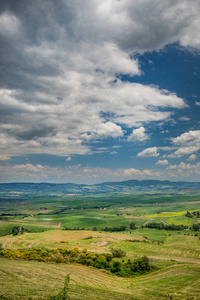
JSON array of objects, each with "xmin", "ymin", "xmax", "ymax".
[{"xmin": 0, "ymin": 259, "xmax": 200, "ymax": 300}]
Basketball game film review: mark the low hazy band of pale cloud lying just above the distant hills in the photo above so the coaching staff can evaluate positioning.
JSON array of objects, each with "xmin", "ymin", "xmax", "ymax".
[{"xmin": 0, "ymin": 162, "xmax": 200, "ymax": 183}]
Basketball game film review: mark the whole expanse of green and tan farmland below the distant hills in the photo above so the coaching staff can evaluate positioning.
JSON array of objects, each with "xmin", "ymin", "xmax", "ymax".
[{"xmin": 0, "ymin": 186, "xmax": 200, "ymax": 300}]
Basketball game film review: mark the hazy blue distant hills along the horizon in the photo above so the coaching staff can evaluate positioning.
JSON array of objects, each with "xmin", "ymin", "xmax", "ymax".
[{"xmin": 0, "ymin": 180, "xmax": 200, "ymax": 194}]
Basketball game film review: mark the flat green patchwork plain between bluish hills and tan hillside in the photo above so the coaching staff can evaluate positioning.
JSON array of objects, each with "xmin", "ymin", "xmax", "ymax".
[{"xmin": 1, "ymin": 192, "xmax": 200, "ymax": 229}]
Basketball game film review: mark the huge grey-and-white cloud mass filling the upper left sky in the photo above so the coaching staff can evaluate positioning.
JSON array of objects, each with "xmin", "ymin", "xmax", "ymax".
[{"xmin": 0, "ymin": 0, "xmax": 200, "ymax": 162}]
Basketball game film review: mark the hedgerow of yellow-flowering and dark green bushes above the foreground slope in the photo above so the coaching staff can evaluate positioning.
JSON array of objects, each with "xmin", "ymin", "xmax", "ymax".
[{"xmin": 0, "ymin": 247, "xmax": 151, "ymax": 276}]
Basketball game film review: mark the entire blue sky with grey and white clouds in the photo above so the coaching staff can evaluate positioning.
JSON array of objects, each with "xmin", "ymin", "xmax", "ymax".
[{"xmin": 0, "ymin": 0, "xmax": 200, "ymax": 184}]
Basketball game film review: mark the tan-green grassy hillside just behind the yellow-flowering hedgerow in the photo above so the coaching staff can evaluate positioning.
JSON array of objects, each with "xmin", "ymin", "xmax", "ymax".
[{"xmin": 0, "ymin": 228, "xmax": 200, "ymax": 262}]
